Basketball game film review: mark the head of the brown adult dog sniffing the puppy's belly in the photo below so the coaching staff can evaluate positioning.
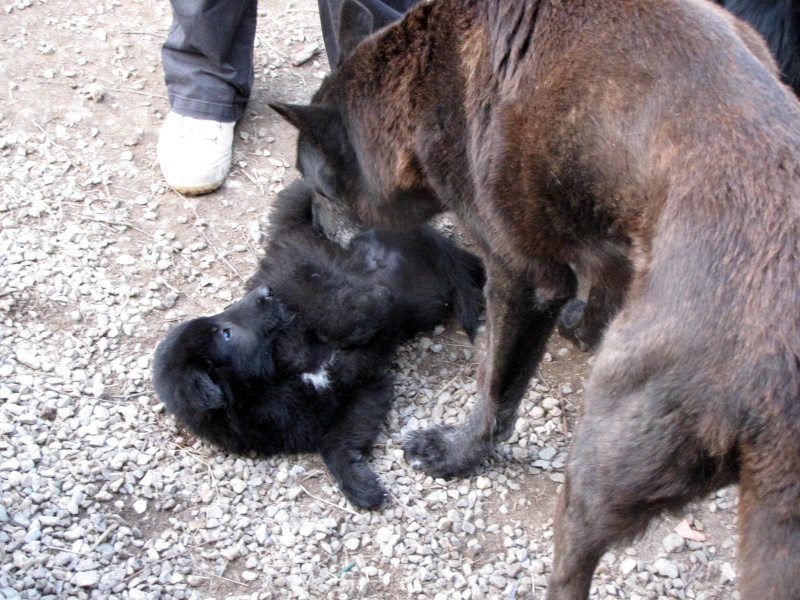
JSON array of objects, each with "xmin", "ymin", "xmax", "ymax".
[{"xmin": 270, "ymin": 0, "xmax": 442, "ymax": 241}]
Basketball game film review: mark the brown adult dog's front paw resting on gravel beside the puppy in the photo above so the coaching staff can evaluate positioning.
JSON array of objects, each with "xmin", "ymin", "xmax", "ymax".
[{"xmin": 403, "ymin": 425, "xmax": 486, "ymax": 478}]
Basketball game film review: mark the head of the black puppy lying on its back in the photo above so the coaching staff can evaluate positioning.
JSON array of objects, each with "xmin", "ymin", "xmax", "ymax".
[{"xmin": 153, "ymin": 286, "xmax": 288, "ymax": 442}]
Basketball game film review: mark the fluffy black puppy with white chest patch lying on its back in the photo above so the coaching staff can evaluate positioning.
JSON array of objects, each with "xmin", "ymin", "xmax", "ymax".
[{"xmin": 153, "ymin": 182, "xmax": 484, "ymax": 508}]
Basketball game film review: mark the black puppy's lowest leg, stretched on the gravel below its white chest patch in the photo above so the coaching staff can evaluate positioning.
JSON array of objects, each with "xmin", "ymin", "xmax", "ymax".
[{"xmin": 320, "ymin": 374, "xmax": 394, "ymax": 508}]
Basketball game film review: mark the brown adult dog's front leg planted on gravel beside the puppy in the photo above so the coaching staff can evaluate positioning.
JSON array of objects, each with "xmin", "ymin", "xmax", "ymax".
[{"xmin": 404, "ymin": 260, "xmax": 576, "ymax": 477}]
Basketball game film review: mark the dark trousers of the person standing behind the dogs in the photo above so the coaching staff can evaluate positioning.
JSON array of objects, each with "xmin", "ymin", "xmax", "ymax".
[{"xmin": 161, "ymin": 0, "xmax": 418, "ymax": 122}]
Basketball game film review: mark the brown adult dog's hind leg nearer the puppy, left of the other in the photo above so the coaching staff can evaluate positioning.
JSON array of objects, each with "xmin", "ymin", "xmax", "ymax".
[{"xmin": 547, "ymin": 364, "xmax": 736, "ymax": 600}]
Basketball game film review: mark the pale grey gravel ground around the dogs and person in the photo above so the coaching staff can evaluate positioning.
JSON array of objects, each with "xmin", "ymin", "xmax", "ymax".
[{"xmin": 0, "ymin": 0, "xmax": 738, "ymax": 600}]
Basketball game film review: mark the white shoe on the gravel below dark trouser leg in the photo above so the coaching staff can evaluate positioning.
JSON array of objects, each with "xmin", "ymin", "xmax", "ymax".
[{"xmin": 156, "ymin": 112, "xmax": 236, "ymax": 195}]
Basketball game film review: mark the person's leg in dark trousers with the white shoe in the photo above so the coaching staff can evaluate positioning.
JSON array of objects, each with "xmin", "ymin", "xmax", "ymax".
[{"xmin": 158, "ymin": 0, "xmax": 257, "ymax": 194}]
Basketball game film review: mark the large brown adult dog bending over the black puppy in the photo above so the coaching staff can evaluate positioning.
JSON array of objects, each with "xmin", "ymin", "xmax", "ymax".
[{"xmin": 275, "ymin": 0, "xmax": 800, "ymax": 600}]
